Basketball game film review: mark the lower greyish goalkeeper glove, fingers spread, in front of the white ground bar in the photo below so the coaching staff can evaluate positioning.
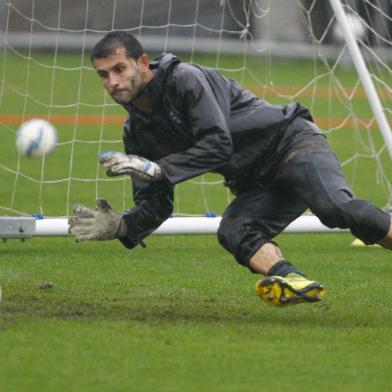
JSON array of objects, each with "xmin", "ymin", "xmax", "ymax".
[{"xmin": 68, "ymin": 199, "xmax": 126, "ymax": 242}]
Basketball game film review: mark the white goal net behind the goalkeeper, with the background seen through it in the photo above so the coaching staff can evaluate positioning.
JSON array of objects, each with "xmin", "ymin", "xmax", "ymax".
[{"xmin": 0, "ymin": 0, "xmax": 392, "ymax": 236}]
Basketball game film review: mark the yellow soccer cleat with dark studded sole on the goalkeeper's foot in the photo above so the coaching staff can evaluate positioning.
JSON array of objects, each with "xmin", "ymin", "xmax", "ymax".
[{"xmin": 256, "ymin": 276, "xmax": 324, "ymax": 306}]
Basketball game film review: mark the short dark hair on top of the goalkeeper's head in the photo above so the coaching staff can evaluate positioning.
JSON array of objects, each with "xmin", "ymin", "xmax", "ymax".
[{"xmin": 91, "ymin": 31, "xmax": 144, "ymax": 61}]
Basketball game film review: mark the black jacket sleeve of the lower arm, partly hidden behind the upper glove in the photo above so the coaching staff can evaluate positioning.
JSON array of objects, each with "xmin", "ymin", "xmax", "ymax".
[{"xmin": 119, "ymin": 120, "xmax": 173, "ymax": 248}]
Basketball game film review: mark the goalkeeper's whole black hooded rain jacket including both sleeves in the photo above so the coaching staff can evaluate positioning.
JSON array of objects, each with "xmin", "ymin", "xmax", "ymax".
[{"xmin": 121, "ymin": 54, "xmax": 312, "ymax": 248}]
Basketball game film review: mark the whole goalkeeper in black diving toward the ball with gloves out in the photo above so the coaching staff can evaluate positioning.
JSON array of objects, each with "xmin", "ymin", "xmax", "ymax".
[{"xmin": 69, "ymin": 31, "xmax": 392, "ymax": 306}]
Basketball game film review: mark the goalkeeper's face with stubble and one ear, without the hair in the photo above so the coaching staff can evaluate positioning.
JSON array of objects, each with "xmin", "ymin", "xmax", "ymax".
[{"xmin": 94, "ymin": 47, "xmax": 149, "ymax": 104}]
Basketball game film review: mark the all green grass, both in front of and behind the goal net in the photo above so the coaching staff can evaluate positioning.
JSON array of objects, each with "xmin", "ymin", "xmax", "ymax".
[{"xmin": 0, "ymin": 53, "xmax": 392, "ymax": 392}]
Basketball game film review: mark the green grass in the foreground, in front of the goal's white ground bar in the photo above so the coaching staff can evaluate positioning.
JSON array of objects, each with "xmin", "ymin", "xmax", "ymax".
[{"xmin": 0, "ymin": 234, "xmax": 392, "ymax": 392}]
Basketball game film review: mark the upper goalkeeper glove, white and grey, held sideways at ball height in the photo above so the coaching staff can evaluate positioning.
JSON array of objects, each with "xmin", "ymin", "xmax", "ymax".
[{"xmin": 99, "ymin": 151, "xmax": 162, "ymax": 182}]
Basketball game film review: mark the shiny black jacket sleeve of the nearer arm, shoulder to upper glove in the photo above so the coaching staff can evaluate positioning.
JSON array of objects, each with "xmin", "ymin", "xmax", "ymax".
[{"xmin": 157, "ymin": 64, "xmax": 233, "ymax": 184}]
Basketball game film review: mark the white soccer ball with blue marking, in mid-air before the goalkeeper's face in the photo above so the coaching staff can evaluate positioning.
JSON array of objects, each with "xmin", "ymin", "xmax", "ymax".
[{"xmin": 16, "ymin": 119, "xmax": 57, "ymax": 156}]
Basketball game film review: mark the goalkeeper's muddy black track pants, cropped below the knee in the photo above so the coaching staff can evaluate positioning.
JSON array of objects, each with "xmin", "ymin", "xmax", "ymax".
[{"xmin": 218, "ymin": 135, "xmax": 391, "ymax": 266}]
